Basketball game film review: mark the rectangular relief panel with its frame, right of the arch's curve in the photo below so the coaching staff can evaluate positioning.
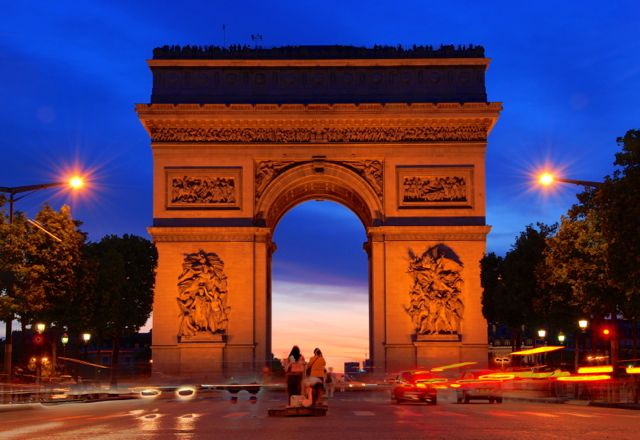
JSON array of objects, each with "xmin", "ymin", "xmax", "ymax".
[{"xmin": 396, "ymin": 165, "xmax": 474, "ymax": 208}]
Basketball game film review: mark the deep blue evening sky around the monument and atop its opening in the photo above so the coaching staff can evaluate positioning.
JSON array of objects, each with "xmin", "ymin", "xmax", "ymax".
[{"xmin": 0, "ymin": 0, "xmax": 640, "ymax": 364}]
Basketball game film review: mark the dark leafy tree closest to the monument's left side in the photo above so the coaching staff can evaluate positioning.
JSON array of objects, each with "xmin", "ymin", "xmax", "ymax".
[{"xmin": 83, "ymin": 234, "xmax": 158, "ymax": 384}]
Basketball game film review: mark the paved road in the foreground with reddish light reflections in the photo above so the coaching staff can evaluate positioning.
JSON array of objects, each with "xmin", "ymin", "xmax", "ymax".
[{"xmin": 0, "ymin": 392, "xmax": 640, "ymax": 440}]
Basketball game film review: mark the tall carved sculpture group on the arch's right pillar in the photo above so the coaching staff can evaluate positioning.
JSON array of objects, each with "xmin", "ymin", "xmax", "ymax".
[{"xmin": 404, "ymin": 244, "xmax": 464, "ymax": 335}]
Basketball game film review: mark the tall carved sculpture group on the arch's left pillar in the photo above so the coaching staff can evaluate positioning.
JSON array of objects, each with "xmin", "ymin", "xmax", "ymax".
[{"xmin": 177, "ymin": 249, "xmax": 230, "ymax": 339}]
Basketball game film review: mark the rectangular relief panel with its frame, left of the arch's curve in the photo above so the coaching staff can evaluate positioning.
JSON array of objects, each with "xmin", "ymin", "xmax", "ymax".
[{"xmin": 165, "ymin": 167, "xmax": 242, "ymax": 209}]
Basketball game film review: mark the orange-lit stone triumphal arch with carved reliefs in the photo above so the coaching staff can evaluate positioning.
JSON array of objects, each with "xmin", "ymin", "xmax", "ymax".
[{"xmin": 136, "ymin": 46, "xmax": 502, "ymax": 378}]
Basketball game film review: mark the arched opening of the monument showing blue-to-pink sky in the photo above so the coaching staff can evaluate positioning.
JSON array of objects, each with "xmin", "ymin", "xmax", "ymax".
[{"xmin": 271, "ymin": 200, "xmax": 370, "ymax": 372}]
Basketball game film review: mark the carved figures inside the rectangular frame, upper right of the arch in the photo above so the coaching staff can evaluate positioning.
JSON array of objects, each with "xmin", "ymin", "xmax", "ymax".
[{"xmin": 402, "ymin": 176, "xmax": 467, "ymax": 202}]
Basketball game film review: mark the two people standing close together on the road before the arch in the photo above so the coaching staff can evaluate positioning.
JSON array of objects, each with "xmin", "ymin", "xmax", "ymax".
[{"xmin": 285, "ymin": 345, "xmax": 327, "ymax": 405}]
